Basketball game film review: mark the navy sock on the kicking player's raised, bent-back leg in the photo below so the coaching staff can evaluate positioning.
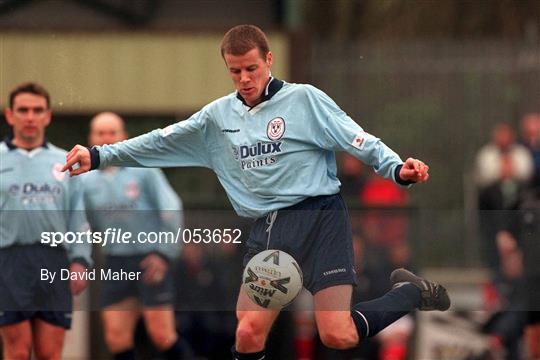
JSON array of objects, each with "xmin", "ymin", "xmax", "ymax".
[{"xmin": 351, "ymin": 283, "xmax": 421, "ymax": 339}]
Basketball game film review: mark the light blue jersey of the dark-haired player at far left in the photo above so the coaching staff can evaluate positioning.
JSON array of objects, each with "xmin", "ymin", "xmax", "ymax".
[{"xmin": 0, "ymin": 140, "xmax": 92, "ymax": 265}]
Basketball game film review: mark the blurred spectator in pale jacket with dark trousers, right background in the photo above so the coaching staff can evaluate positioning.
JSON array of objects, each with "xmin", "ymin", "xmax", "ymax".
[{"xmin": 475, "ymin": 123, "xmax": 533, "ymax": 272}]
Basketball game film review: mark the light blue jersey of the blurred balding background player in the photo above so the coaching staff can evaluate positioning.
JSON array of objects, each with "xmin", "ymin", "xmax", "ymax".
[{"xmin": 82, "ymin": 167, "xmax": 183, "ymax": 259}]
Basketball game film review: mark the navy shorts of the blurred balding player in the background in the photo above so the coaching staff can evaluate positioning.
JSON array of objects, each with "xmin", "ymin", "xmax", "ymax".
[{"xmin": 100, "ymin": 255, "xmax": 174, "ymax": 307}]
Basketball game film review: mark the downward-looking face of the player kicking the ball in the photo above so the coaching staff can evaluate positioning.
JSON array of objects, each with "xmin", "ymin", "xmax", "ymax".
[{"xmin": 224, "ymin": 48, "xmax": 272, "ymax": 106}]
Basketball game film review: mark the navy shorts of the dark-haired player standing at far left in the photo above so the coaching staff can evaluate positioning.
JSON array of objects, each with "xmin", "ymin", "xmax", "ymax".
[{"xmin": 0, "ymin": 244, "xmax": 72, "ymax": 329}]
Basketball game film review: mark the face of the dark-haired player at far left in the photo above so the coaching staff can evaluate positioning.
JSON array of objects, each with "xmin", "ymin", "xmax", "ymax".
[{"xmin": 5, "ymin": 93, "xmax": 51, "ymax": 144}]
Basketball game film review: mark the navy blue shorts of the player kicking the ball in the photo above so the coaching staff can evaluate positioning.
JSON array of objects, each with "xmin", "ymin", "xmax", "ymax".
[{"xmin": 244, "ymin": 194, "xmax": 358, "ymax": 294}]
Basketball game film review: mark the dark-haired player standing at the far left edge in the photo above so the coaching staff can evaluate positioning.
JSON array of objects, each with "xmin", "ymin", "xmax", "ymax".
[{"xmin": 0, "ymin": 83, "xmax": 91, "ymax": 360}]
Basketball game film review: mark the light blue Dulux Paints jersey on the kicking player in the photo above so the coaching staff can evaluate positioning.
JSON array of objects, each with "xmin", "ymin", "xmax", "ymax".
[{"xmin": 98, "ymin": 79, "xmax": 403, "ymax": 218}]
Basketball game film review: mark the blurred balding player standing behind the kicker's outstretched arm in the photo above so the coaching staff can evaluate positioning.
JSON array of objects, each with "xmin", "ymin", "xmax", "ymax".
[{"xmin": 83, "ymin": 112, "xmax": 186, "ymax": 359}]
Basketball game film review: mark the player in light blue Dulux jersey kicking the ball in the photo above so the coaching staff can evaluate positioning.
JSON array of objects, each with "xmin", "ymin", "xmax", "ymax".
[{"xmin": 64, "ymin": 25, "xmax": 450, "ymax": 360}]
